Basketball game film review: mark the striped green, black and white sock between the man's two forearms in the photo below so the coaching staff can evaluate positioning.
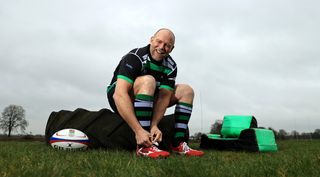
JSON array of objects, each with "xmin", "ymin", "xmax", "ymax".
[{"xmin": 134, "ymin": 94, "xmax": 153, "ymax": 132}]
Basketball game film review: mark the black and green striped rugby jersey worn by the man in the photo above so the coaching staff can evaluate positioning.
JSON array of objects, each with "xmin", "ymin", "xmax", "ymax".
[{"xmin": 107, "ymin": 45, "xmax": 177, "ymax": 92}]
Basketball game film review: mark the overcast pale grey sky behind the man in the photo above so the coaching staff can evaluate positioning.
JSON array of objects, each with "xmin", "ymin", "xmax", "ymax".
[{"xmin": 0, "ymin": 0, "xmax": 320, "ymax": 134}]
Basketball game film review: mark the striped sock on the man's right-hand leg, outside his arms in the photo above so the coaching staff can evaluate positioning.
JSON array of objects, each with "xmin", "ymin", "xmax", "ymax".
[{"xmin": 172, "ymin": 102, "xmax": 192, "ymax": 147}]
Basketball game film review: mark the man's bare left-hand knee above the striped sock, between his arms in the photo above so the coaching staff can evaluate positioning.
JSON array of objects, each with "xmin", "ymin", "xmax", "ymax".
[{"xmin": 133, "ymin": 75, "xmax": 157, "ymax": 94}]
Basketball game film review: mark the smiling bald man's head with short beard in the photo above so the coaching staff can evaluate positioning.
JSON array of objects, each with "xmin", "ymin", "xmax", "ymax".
[{"xmin": 150, "ymin": 28, "xmax": 175, "ymax": 61}]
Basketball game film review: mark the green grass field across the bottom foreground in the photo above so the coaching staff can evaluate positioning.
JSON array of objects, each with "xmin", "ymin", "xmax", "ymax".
[{"xmin": 0, "ymin": 140, "xmax": 320, "ymax": 177}]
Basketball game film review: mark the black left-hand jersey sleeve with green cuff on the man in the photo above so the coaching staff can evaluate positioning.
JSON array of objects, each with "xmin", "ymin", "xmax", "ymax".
[{"xmin": 117, "ymin": 53, "xmax": 142, "ymax": 84}]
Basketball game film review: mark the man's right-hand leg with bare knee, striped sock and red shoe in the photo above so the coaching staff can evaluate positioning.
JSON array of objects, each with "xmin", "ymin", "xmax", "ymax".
[{"xmin": 171, "ymin": 84, "xmax": 204, "ymax": 156}]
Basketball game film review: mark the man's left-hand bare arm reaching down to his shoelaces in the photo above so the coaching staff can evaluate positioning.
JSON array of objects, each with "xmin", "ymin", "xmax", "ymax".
[{"xmin": 113, "ymin": 79, "xmax": 152, "ymax": 147}]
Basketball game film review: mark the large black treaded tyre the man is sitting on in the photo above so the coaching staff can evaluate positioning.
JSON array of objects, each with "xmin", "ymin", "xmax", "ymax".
[{"xmin": 45, "ymin": 108, "xmax": 185, "ymax": 150}]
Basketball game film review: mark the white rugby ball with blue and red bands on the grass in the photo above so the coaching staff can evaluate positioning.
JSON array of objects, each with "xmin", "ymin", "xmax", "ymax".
[{"xmin": 50, "ymin": 128, "xmax": 89, "ymax": 150}]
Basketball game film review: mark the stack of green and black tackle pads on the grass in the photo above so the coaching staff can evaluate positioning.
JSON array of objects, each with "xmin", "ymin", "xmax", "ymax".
[{"xmin": 200, "ymin": 116, "xmax": 278, "ymax": 152}]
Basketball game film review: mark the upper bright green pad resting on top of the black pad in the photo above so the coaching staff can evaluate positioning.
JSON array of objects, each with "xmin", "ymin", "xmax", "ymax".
[{"xmin": 221, "ymin": 115, "xmax": 257, "ymax": 138}]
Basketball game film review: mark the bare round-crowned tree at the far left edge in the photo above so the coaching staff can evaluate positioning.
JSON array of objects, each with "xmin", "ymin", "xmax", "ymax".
[{"xmin": 0, "ymin": 105, "xmax": 28, "ymax": 137}]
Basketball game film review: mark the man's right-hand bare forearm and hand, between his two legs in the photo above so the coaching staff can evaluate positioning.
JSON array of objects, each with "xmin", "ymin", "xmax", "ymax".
[{"xmin": 151, "ymin": 89, "xmax": 173, "ymax": 142}]
